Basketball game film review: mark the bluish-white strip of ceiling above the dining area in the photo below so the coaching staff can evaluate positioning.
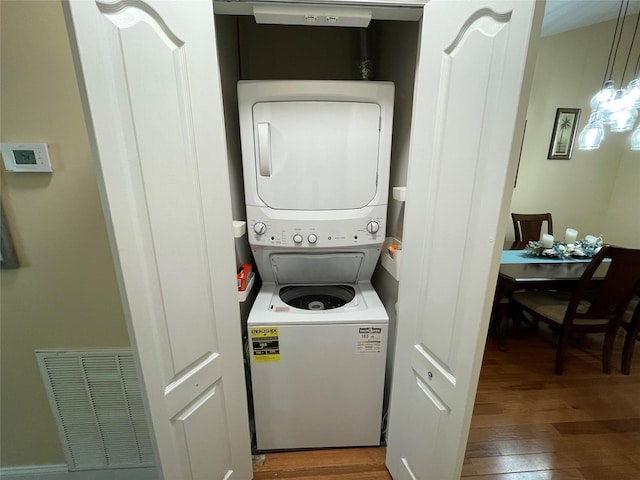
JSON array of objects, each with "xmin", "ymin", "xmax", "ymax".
[{"xmin": 542, "ymin": 0, "xmax": 640, "ymax": 37}]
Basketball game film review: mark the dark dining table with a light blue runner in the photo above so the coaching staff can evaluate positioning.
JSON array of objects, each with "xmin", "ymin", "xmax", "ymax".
[{"xmin": 492, "ymin": 250, "xmax": 609, "ymax": 350}]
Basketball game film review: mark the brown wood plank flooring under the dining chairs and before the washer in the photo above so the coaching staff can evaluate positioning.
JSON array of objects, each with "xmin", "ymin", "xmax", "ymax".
[{"xmin": 254, "ymin": 327, "xmax": 640, "ymax": 480}]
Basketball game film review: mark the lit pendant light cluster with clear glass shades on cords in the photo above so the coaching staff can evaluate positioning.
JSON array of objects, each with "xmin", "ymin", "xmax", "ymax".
[{"xmin": 578, "ymin": 0, "xmax": 640, "ymax": 150}]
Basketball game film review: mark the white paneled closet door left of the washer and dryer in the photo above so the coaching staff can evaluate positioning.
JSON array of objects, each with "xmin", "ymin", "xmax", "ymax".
[{"xmin": 63, "ymin": 0, "xmax": 252, "ymax": 480}]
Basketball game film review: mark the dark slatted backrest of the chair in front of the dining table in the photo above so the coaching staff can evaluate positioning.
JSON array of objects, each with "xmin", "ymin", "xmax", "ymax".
[{"xmin": 565, "ymin": 246, "xmax": 640, "ymax": 321}]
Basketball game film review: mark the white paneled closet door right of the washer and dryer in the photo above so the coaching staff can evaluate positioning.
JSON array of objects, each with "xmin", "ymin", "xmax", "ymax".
[{"xmin": 387, "ymin": 0, "xmax": 544, "ymax": 480}]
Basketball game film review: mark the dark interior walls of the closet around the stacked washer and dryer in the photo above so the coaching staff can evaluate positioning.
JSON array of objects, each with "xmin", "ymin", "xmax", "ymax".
[{"xmin": 215, "ymin": 14, "xmax": 420, "ymax": 432}]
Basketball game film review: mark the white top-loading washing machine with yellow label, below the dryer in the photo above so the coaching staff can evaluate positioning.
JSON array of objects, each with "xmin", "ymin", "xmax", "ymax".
[{"xmin": 248, "ymin": 282, "xmax": 388, "ymax": 450}]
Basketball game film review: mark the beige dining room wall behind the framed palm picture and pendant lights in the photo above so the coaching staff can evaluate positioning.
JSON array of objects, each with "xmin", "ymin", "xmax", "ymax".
[{"xmin": 505, "ymin": 15, "xmax": 640, "ymax": 248}]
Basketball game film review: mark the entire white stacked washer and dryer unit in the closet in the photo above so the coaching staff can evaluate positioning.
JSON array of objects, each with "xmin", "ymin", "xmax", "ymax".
[{"xmin": 238, "ymin": 81, "xmax": 394, "ymax": 450}]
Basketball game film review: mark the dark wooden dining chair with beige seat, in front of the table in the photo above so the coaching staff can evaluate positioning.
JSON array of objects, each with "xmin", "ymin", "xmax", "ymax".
[{"xmin": 511, "ymin": 246, "xmax": 640, "ymax": 375}]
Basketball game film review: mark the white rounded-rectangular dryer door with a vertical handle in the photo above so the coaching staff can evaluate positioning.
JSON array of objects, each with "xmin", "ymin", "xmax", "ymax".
[{"xmin": 253, "ymin": 101, "xmax": 386, "ymax": 210}]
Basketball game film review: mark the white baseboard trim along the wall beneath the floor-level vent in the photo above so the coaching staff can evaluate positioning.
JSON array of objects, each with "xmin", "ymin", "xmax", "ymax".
[{"xmin": 0, "ymin": 463, "xmax": 160, "ymax": 480}]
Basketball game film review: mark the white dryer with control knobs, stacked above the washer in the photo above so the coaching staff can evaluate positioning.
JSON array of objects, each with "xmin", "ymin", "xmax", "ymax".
[{"xmin": 238, "ymin": 80, "xmax": 394, "ymax": 266}]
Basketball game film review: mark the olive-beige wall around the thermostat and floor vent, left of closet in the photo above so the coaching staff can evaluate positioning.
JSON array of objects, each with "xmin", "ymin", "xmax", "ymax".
[{"xmin": 0, "ymin": 0, "xmax": 129, "ymax": 464}]
